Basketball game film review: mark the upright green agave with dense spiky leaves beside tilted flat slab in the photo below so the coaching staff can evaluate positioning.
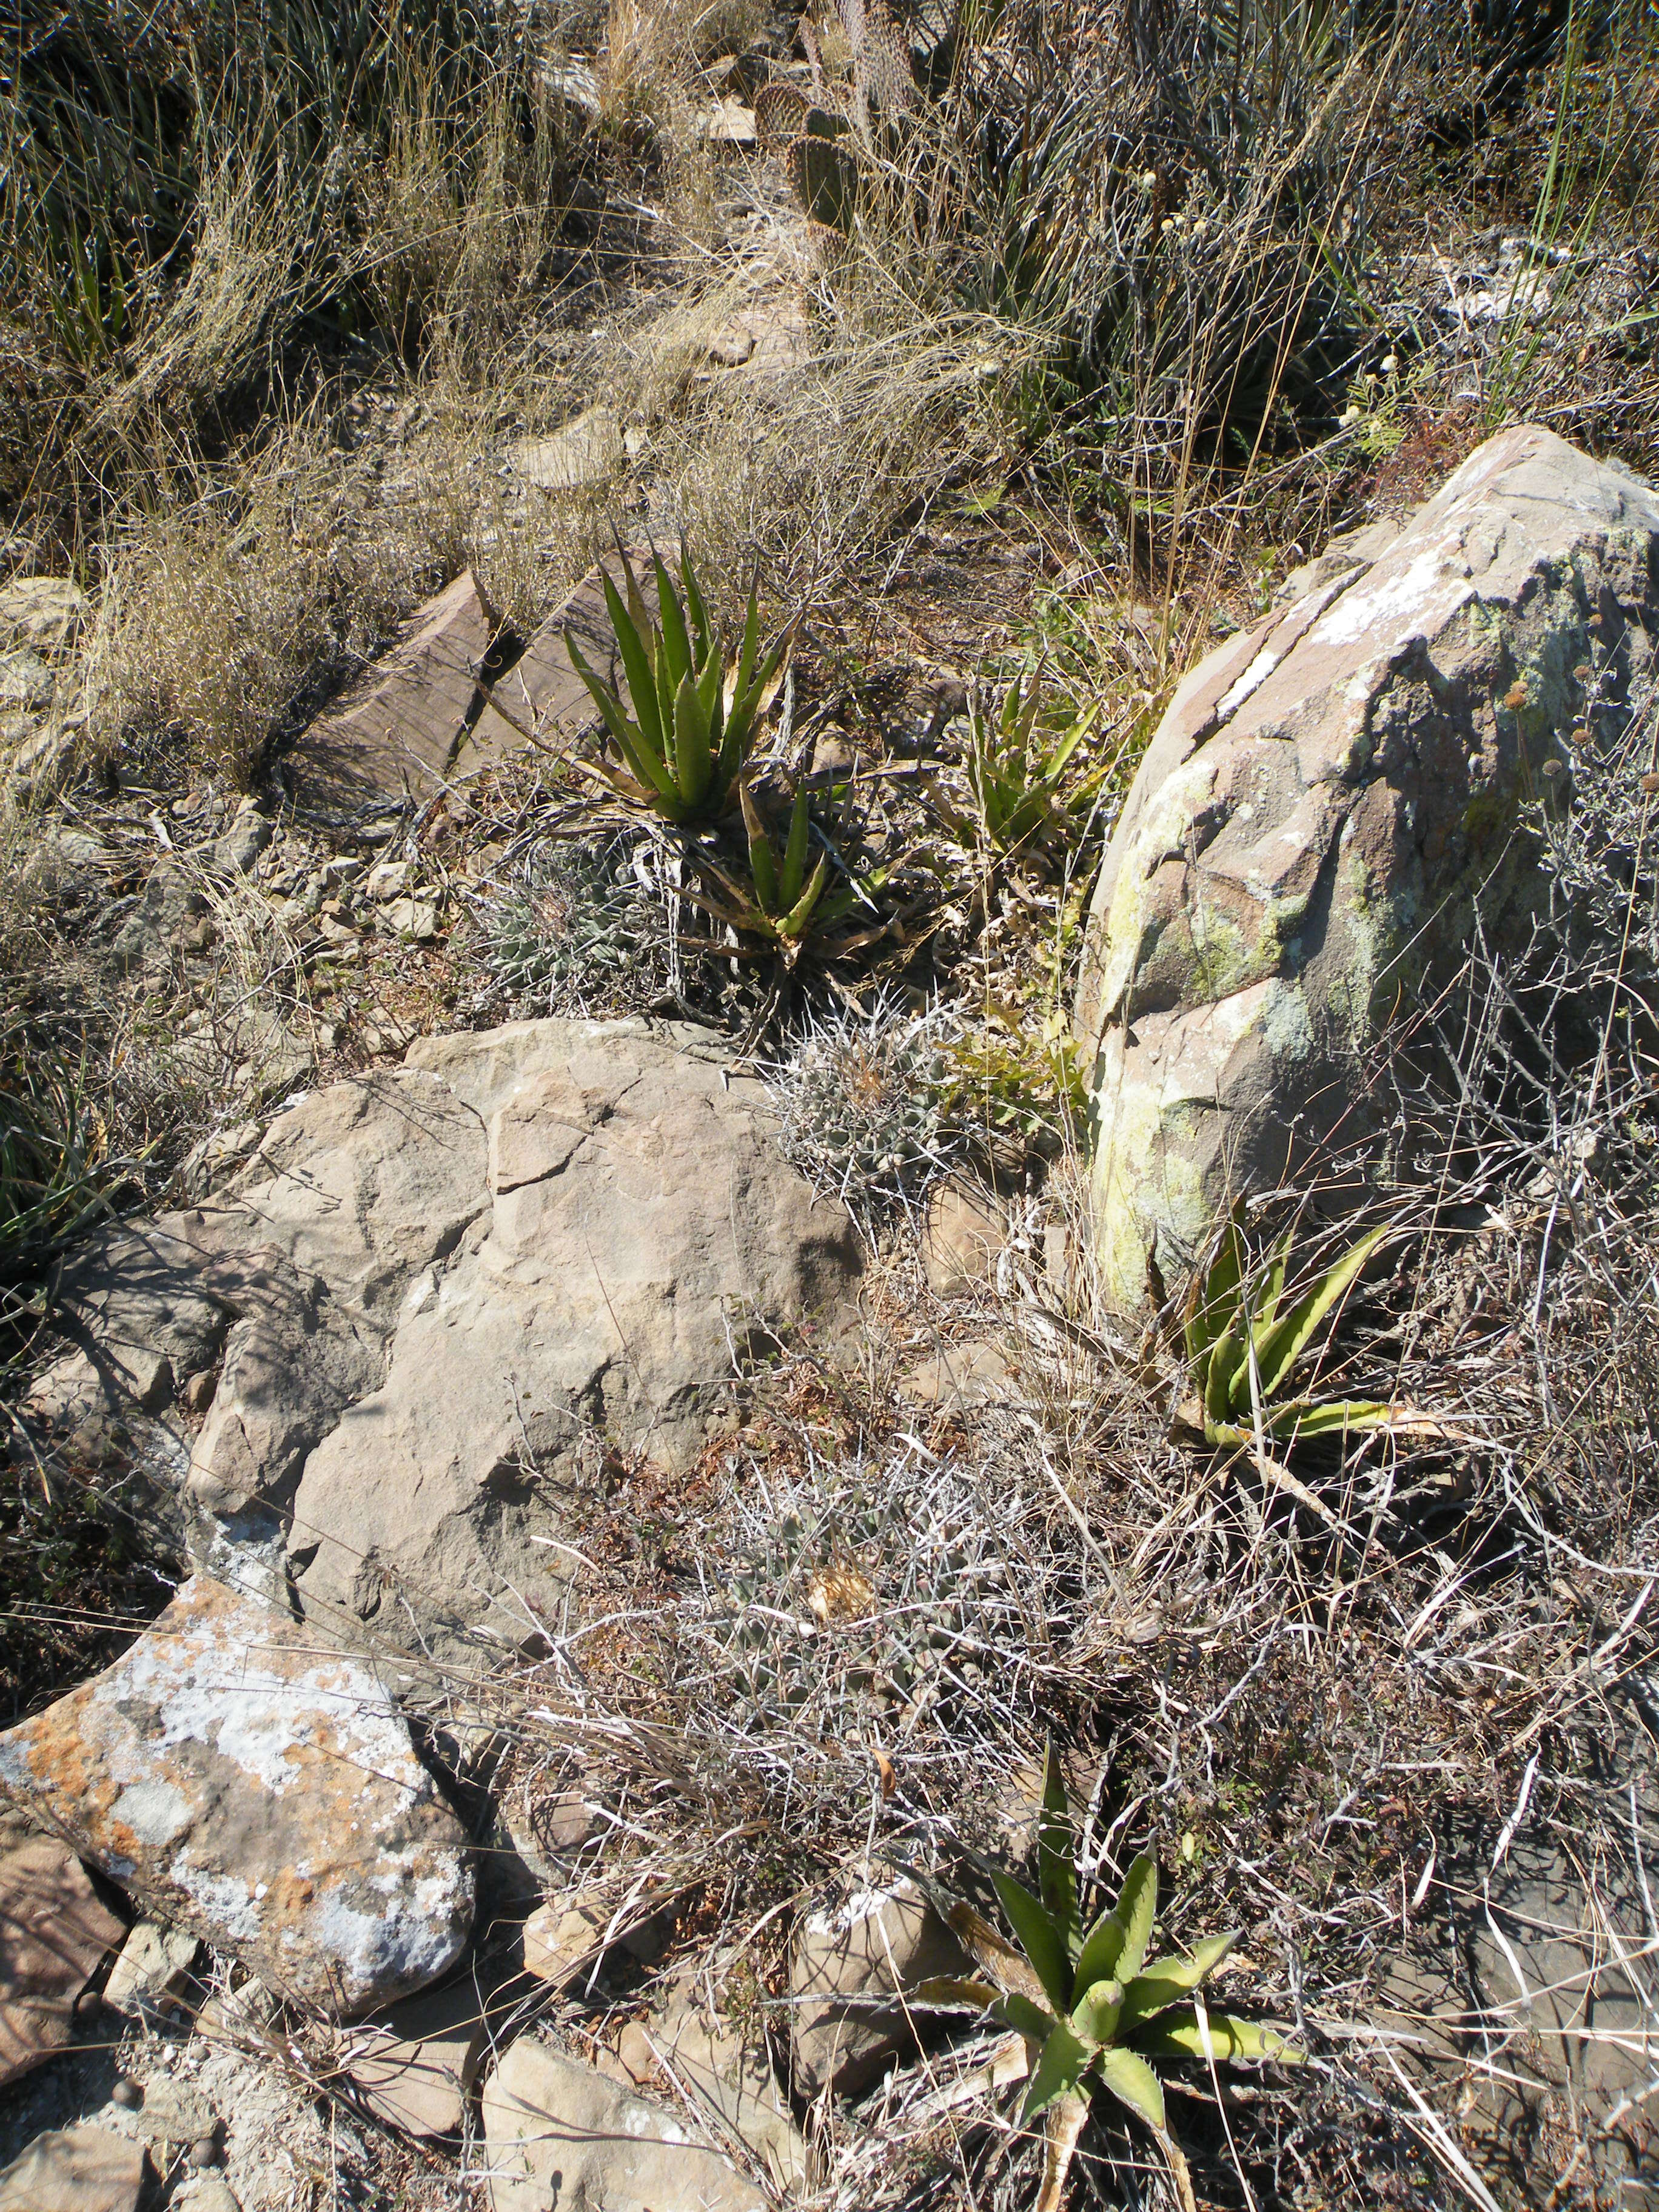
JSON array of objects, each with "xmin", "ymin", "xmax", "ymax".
[{"xmin": 564, "ymin": 553, "xmax": 789, "ymax": 823}]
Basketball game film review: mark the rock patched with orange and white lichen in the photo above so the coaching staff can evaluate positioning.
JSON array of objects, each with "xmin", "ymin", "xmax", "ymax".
[{"xmin": 0, "ymin": 1577, "xmax": 474, "ymax": 2015}]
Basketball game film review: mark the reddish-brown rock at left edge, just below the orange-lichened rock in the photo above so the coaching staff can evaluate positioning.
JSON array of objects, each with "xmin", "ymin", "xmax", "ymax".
[{"xmin": 0, "ymin": 1836, "xmax": 126, "ymax": 2082}]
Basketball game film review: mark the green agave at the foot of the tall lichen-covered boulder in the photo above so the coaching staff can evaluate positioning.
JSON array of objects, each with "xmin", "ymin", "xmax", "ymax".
[{"xmin": 1184, "ymin": 1208, "xmax": 1398, "ymax": 1444}]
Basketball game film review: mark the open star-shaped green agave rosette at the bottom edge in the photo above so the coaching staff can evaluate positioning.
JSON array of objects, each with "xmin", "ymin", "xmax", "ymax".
[{"xmin": 916, "ymin": 1745, "xmax": 1301, "ymax": 2212}]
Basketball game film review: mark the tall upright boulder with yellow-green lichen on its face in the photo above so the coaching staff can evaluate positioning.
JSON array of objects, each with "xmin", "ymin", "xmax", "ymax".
[{"xmin": 1078, "ymin": 429, "xmax": 1659, "ymax": 1312}]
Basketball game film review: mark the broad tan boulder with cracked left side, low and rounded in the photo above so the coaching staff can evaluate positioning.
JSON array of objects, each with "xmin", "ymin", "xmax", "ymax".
[{"xmin": 44, "ymin": 1022, "xmax": 860, "ymax": 1657}]
